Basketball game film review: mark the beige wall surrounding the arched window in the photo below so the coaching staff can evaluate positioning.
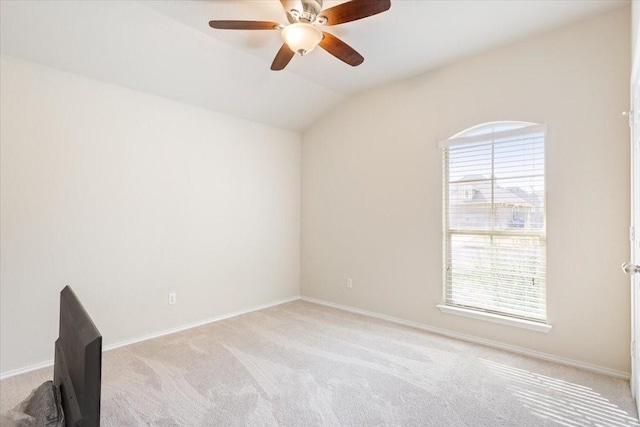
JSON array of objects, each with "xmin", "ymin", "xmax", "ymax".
[{"xmin": 301, "ymin": 7, "xmax": 631, "ymax": 372}]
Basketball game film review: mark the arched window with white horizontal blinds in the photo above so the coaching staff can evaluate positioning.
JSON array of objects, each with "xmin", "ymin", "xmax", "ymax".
[{"xmin": 439, "ymin": 122, "xmax": 546, "ymax": 323}]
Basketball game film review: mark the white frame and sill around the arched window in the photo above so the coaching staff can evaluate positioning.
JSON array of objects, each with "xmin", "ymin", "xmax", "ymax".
[{"xmin": 438, "ymin": 122, "xmax": 551, "ymax": 332}]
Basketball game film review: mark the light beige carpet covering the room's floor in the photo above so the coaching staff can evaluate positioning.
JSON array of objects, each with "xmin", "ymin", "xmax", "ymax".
[{"xmin": 0, "ymin": 301, "xmax": 640, "ymax": 427}]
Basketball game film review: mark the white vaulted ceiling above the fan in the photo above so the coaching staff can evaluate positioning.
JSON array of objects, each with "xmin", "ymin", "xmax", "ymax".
[{"xmin": 0, "ymin": 0, "xmax": 629, "ymax": 131}]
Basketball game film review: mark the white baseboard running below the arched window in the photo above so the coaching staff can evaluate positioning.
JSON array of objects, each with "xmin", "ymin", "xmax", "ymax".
[{"xmin": 300, "ymin": 296, "xmax": 629, "ymax": 380}]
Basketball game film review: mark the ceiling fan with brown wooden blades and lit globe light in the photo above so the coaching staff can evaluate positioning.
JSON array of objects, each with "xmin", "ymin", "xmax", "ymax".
[{"xmin": 209, "ymin": 0, "xmax": 391, "ymax": 71}]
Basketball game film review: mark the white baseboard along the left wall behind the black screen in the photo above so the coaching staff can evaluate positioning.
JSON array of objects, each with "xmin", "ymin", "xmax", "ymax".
[{"xmin": 0, "ymin": 296, "xmax": 300, "ymax": 380}]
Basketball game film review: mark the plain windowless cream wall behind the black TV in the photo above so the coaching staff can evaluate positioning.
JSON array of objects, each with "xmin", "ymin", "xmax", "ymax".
[{"xmin": 0, "ymin": 56, "xmax": 300, "ymax": 374}]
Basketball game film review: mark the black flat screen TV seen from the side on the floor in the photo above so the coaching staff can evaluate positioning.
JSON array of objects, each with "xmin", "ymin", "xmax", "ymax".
[{"xmin": 53, "ymin": 286, "xmax": 102, "ymax": 427}]
